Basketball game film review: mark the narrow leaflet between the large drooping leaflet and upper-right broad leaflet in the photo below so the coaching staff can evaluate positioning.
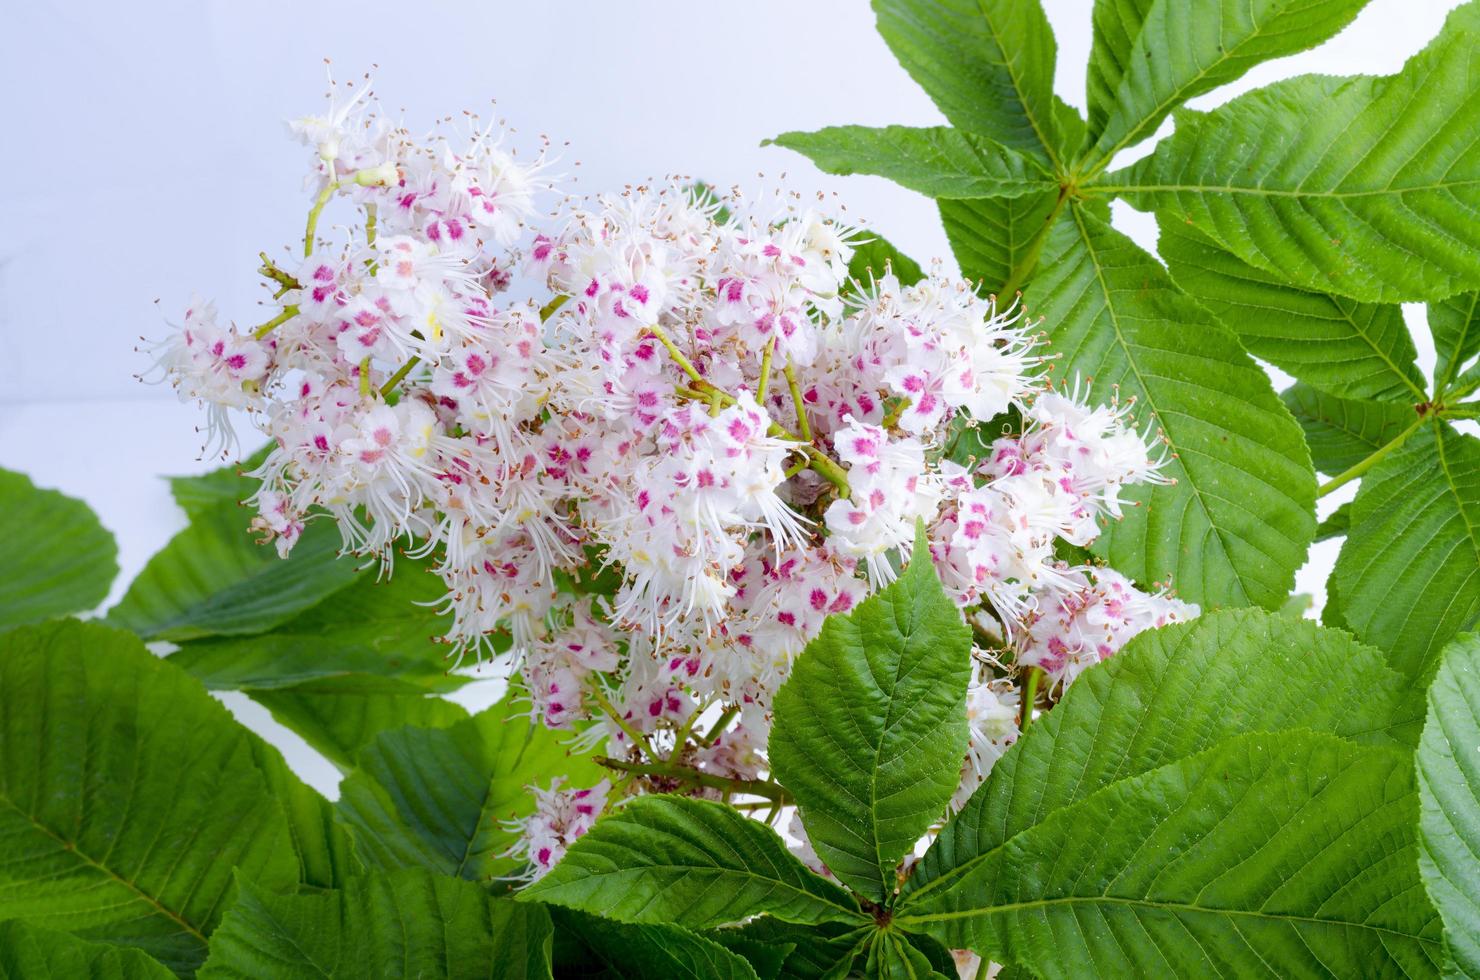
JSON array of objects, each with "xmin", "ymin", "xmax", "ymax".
[{"xmin": 1157, "ymin": 215, "xmax": 1428, "ymax": 406}]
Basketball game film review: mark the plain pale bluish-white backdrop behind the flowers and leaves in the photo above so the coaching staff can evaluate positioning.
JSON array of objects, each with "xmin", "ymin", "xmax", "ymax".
[{"xmin": 0, "ymin": 0, "xmax": 1455, "ymax": 795}]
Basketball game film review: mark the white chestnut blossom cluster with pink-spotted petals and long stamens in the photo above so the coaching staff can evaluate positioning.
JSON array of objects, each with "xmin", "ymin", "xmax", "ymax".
[{"xmin": 150, "ymin": 84, "xmax": 1196, "ymax": 873}]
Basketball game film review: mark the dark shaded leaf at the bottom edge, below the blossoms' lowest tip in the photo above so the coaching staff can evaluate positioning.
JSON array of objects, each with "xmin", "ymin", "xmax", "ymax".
[{"xmin": 551, "ymin": 907, "xmax": 763, "ymax": 980}]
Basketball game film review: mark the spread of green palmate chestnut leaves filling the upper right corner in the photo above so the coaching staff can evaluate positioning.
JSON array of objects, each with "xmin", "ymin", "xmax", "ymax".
[{"xmin": 776, "ymin": 0, "xmax": 1480, "ymax": 645}]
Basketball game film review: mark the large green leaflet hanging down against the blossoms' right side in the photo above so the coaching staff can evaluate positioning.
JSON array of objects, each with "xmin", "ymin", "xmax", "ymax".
[{"xmin": 1024, "ymin": 206, "xmax": 1316, "ymax": 608}]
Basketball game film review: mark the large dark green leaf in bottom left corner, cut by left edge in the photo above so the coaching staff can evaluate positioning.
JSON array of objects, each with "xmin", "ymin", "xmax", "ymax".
[{"xmin": 0, "ymin": 622, "xmax": 299, "ymax": 973}]
